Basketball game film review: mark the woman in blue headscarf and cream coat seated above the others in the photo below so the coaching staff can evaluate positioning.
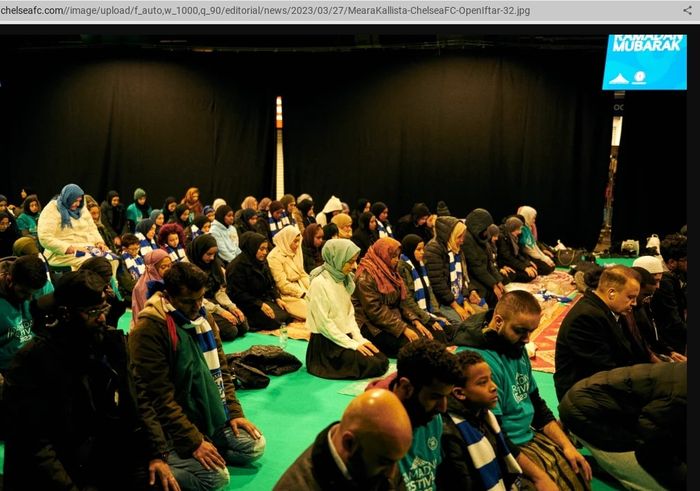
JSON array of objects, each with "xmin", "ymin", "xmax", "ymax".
[{"xmin": 37, "ymin": 184, "xmax": 113, "ymax": 275}]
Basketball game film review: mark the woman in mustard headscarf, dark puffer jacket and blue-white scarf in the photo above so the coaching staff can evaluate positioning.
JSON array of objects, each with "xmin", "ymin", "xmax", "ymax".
[{"xmin": 424, "ymin": 216, "xmax": 480, "ymax": 326}]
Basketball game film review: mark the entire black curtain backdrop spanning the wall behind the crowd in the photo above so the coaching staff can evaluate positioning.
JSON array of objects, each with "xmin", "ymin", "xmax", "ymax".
[{"xmin": 0, "ymin": 42, "xmax": 686, "ymax": 249}]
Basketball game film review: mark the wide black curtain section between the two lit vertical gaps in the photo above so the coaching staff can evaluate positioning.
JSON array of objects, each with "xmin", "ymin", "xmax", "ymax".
[{"xmin": 284, "ymin": 51, "xmax": 612, "ymax": 248}]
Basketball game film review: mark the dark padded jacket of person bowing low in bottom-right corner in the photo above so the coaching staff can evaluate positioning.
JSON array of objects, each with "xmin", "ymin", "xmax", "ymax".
[{"xmin": 559, "ymin": 362, "xmax": 688, "ymax": 489}]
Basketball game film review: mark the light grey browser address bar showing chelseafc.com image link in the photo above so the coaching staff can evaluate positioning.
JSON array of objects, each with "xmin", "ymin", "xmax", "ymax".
[{"xmin": 0, "ymin": 0, "xmax": 700, "ymax": 25}]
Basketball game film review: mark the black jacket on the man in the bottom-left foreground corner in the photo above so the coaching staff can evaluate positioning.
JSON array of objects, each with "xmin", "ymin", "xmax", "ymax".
[{"xmin": 5, "ymin": 324, "xmax": 159, "ymax": 491}]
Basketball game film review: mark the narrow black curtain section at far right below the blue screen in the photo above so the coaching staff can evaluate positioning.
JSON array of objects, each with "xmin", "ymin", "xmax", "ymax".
[{"xmin": 612, "ymin": 91, "xmax": 688, "ymax": 245}]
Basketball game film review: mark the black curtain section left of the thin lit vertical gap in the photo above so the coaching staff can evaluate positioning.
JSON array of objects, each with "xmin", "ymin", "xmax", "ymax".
[{"xmin": 0, "ymin": 50, "xmax": 275, "ymax": 208}]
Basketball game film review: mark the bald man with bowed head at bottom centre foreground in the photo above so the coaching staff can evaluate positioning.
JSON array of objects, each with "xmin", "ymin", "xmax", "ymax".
[{"xmin": 274, "ymin": 389, "xmax": 412, "ymax": 491}]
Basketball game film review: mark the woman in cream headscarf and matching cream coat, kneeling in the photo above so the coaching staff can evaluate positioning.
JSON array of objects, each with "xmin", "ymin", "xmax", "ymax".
[{"xmin": 267, "ymin": 225, "xmax": 309, "ymax": 320}]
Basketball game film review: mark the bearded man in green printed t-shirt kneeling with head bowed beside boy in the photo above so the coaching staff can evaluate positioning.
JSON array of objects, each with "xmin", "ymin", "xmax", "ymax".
[{"xmin": 465, "ymin": 290, "xmax": 591, "ymax": 491}]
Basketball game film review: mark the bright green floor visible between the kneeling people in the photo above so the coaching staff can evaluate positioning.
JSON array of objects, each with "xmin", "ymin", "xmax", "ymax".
[{"xmin": 0, "ymin": 313, "xmax": 623, "ymax": 491}]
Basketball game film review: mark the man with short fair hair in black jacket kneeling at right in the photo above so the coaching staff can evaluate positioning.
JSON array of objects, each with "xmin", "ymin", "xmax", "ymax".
[{"xmin": 554, "ymin": 265, "xmax": 649, "ymax": 401}]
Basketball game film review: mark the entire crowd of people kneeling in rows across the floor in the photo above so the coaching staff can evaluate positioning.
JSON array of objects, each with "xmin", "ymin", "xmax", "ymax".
[{"xmin": 0, "ymin": 183, "xmax": 687, "ymax": 490}]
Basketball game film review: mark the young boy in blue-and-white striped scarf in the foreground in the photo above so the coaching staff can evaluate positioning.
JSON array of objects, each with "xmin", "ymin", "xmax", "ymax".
[{"xmin": 437, "ymin": 350, "xmax": 522, "ymax": 491}]
